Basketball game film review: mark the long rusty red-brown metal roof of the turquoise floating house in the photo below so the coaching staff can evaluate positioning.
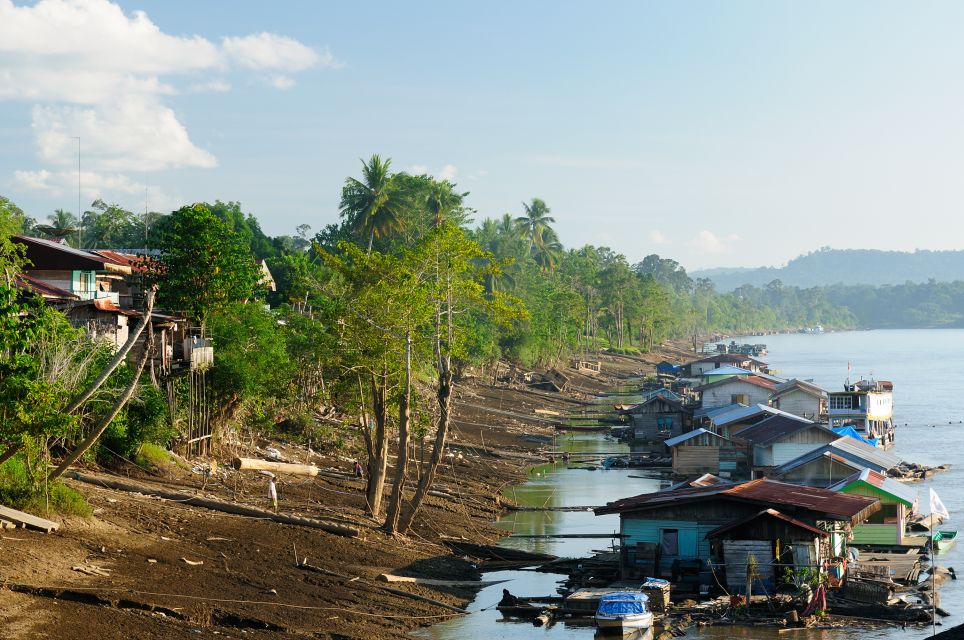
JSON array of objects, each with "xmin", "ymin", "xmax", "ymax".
[{"xmin": 595, "ymin": 478, "xmax": 880, "ymax": 521}]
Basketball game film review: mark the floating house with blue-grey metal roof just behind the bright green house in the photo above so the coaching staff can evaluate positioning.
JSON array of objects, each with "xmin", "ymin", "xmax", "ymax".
[{"xmin": 769, "ymin": 436, "xmax": 900, "ymax": 487}]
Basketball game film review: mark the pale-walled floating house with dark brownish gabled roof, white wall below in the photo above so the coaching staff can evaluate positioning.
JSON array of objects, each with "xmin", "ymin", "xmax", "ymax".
[{"xmin": 730, "ymin": 414, "xmax": 840, "ymax": 468}]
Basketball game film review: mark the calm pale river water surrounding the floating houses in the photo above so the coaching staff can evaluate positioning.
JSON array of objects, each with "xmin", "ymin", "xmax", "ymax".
[{"xmin": 416, "ymin": 329, "xmax": 964, "ymax": 640}]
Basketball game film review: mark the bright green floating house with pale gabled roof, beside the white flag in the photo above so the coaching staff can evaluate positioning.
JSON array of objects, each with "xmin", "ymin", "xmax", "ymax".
[{"xmin": 827, "ymin": 469, "xmax": 917, "ymax": 546}]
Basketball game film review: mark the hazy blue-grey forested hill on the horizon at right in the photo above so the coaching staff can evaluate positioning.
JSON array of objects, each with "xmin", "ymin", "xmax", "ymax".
[{"xmin": 690, "ymin": 247, "xmax": 964, "ymax": 291}]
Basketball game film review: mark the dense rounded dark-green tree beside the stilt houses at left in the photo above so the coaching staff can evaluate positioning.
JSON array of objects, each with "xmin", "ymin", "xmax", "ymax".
[{"xmin": 149, "ymin": 204, "xmax": 261, "ymax": 331}]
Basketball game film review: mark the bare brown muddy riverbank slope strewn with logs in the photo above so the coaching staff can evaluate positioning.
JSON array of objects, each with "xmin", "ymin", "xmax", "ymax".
[{"xmin": 0, "ymin": 342, "xmax": 692, "ymax": 640}]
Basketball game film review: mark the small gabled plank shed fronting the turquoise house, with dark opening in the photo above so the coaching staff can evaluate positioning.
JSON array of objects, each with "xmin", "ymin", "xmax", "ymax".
[{"xmin": 706, "ymin": 508, "xmax": 832, "ymax": 595}]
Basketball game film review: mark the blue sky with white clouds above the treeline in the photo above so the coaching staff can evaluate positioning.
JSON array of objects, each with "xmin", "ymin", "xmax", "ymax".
[{"xmin": 0, "ymin": 0, "xmax": 964, "ymax": 270}]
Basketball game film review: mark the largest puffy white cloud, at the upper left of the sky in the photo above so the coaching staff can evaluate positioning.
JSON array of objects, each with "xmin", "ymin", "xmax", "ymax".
[{"xmin": 0, "ymin": 0, "xmax": 339, "ymax": 195}]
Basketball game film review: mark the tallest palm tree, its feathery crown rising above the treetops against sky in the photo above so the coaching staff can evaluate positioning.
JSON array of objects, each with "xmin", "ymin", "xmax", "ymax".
[{"xmin": 340, "ymin": 154, "xmax": 411, "ymax": 253}]
